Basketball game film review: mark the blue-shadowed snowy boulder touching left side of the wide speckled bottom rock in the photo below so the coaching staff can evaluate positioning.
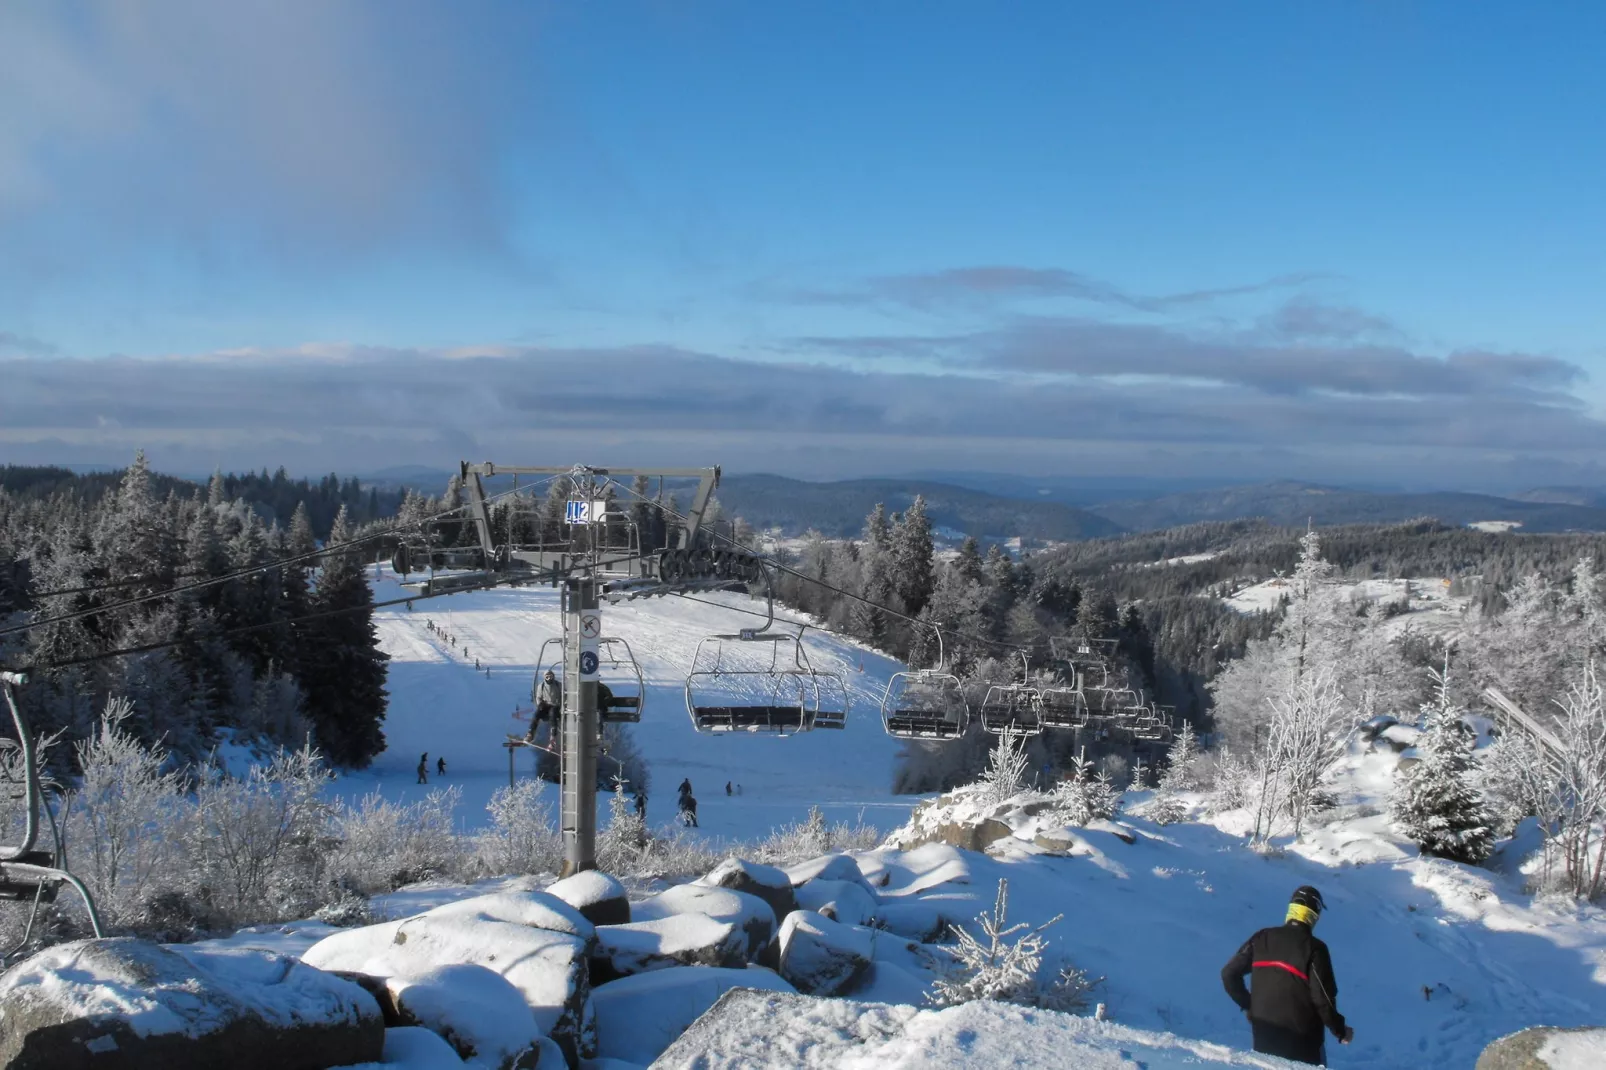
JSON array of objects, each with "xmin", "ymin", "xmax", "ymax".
[{"xmin": 596, "ymin": 966, "xmax": 793, "ymax": 1065}]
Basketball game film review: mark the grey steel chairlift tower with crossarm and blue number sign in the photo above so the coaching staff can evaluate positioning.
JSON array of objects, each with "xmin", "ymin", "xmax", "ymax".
[{"xmin": 392, "ymin": 461, "xmax": 738, "ymax": 877}]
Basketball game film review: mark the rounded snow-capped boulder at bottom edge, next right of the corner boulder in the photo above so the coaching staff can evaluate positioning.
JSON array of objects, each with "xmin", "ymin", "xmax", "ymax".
[{"xmin": 385, "ymin": 964, "xmax": 541, "ymax": 1070}]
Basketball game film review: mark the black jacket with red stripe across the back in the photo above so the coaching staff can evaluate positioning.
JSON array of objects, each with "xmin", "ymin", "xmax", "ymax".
[{"xmin": 1221, "ymin": 922, "xmax": 1344, "ymax": 1051}]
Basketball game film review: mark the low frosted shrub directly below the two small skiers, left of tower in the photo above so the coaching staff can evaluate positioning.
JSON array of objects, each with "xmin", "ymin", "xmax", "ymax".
[{"xmin": 329, "ymin": 786, "xmax": 467, "ymax": 895}]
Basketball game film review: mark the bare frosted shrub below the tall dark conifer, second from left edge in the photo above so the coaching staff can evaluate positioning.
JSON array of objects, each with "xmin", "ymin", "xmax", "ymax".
[{"xmin": 180, "ymin": 747, "xmax": 331, "ymax": 924}]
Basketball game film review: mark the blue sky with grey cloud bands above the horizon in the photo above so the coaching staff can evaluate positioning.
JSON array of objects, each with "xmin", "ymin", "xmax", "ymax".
[{"xmin": 0, "ymin": 0, "xmax": 1606, "ymax": 488}]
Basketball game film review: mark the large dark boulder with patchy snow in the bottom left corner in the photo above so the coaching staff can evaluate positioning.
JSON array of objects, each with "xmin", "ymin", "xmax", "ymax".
[{"xmin": 0, "ymin": 938, "xmax": 385, "ymax": 1070}]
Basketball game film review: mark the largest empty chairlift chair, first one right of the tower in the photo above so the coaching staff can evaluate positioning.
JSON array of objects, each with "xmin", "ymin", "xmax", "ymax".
[{"xmin": 686, "ymin": 628, "xmax": 848, "ymax": 736}]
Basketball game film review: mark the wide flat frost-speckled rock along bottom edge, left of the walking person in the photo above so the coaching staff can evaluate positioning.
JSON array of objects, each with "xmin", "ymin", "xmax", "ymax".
[{"xmin": 654, "ymin": 990, "xmax": 1297, "ymax": 1070}]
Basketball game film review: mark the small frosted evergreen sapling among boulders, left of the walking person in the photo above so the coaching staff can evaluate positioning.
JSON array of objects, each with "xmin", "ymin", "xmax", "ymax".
[{"xmin": 927, "ymin": 879, "xmax": 1099, "ymax": 1011}]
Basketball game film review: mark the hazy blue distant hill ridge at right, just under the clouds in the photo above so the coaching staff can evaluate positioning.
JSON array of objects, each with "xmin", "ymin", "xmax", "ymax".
[{"xmin": 1090, "ymin": 482, "xmax": 1606, "ymax": 533}]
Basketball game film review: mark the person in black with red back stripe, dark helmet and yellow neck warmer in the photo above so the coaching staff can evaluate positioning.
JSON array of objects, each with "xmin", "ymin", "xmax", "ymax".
[{"xmin": 1221, "ymin": 885, "xmax": 1355, "ymax": 1067}]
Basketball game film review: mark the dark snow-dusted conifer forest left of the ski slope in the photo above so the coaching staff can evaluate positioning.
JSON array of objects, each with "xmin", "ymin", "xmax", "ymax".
[{"xmin": 0, "ymin": 455, "xmax": 385, "ymax": 766}]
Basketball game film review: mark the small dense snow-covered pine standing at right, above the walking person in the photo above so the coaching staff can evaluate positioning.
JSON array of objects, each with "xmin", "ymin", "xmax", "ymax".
[{"xmin": 1392, "ymin": 667, "xmax": 1494, "ymax": 864}]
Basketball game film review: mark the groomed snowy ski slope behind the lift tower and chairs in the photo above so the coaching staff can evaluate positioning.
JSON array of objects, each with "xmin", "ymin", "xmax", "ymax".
[{"xmin": 334, "ymin": 569, "xmax": 919, "ymax": 839}]
